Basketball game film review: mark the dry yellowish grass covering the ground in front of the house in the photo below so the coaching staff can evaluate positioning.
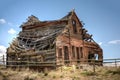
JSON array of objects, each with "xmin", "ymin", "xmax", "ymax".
[{"xmin": 0, "ymin": 67, "xmax": 120, "ymax": 80}]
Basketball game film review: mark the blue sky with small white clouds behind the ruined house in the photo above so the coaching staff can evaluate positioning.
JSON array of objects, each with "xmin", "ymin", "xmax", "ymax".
[{"xmin": 0, "ymin": 0, "xmax": 120, "ymax": 58}]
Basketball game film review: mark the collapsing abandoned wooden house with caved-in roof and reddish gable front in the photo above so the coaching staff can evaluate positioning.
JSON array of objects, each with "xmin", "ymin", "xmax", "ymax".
[{"xmin": 7, "ymin": 11, "xmax": 103, "ymax": 66}]
